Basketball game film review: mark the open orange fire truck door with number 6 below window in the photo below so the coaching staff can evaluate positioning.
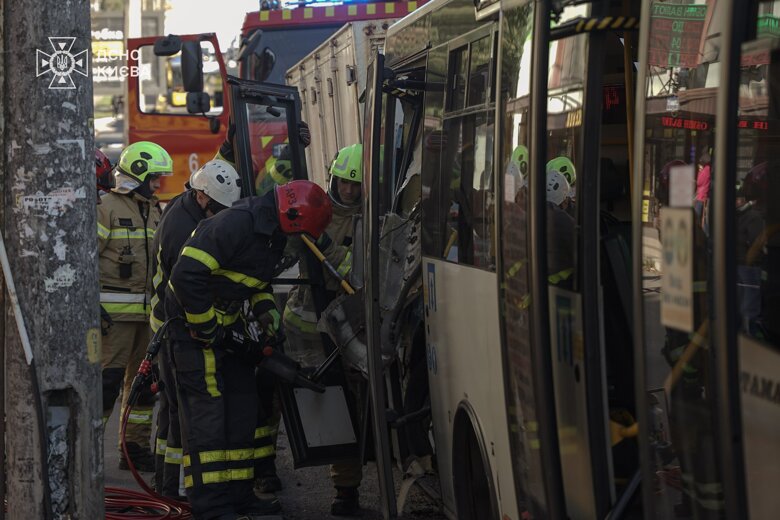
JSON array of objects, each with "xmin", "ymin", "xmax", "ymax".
[{"xmin": 125, "ymin": 34, "xmax": 230, "ymax": 201}]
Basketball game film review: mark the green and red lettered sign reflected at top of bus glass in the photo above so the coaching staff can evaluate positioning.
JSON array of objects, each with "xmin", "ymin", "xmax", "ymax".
[{"xmin": 649, "ymin": 2, "xmax": 707, "ymax": 68}]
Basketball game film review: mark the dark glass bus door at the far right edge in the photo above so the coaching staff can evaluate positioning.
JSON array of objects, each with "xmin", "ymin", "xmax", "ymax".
[{"xmin": 728, "ymin": 0, "xmax": 780, "ymax": 519}]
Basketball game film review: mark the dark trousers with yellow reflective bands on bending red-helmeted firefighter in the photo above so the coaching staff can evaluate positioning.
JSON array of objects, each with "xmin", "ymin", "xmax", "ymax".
[{"xmin": 171, "ymin": 336, "xmax": 257, "ymax": 520}]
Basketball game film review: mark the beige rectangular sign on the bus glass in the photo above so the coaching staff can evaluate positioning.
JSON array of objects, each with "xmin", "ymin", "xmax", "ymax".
[{"xmin": 661, "ymin": 208, "xmax": 693, "ymax": 332}]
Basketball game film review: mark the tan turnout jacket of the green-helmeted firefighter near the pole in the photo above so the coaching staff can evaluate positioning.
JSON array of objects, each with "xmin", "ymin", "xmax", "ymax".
[{"xmin": 97, "ymin": 191, "xmax": 160, "ymax": 321}]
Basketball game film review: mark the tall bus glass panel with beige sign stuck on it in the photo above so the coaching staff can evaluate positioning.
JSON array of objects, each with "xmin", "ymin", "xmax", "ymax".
[{"xmin": 637, "ymin": 0, "xmax": 727, "ymax": 518}]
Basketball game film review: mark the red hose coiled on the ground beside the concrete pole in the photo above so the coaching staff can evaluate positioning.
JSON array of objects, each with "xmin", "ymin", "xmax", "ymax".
[{"xmin": 105, "ymin": 403, "xmax": 192, "ymax": 520}]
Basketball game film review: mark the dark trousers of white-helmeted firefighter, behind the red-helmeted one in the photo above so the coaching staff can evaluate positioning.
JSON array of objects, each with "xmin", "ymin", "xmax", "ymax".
[{"xmin": 154, "ymin": 341, "xmax": 183, "ymax": 497}]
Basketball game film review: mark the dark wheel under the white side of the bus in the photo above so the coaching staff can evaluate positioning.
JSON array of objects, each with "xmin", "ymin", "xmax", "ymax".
[{"xmin": 452, "ymin": 405, "xmax": 499, "ymax": 520}]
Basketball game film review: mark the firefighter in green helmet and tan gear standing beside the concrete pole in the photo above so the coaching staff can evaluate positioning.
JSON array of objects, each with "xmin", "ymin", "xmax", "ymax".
[{"xmin": 97, "ymin": 141, "xmax": 173, "ymax": 471}]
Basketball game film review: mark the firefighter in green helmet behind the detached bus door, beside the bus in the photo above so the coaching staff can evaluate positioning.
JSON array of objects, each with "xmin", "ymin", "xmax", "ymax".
[{"xmin": 283, "ymin": 144, "xmax": 363, "ymax": 516}]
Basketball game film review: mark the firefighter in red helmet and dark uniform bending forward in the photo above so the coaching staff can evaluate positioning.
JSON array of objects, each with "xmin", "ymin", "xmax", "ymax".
[{"xmin": 165, "ymin": 180, "xmax": 332, "ymax": 520}]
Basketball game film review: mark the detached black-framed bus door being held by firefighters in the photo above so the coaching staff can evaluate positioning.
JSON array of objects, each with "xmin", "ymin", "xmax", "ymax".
[{"xmin": 228, "ymin": 77, "xmax": 362, "ymax": 468}]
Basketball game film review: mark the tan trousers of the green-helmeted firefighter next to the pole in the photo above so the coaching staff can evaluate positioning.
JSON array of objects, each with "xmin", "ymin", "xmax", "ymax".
[{"xmin": 102, "ymin": 321, "xmax": 154, "ymax": 451}]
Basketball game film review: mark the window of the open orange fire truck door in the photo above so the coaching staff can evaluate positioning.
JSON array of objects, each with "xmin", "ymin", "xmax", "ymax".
[{"xmin": 138, "ymin": 41, "xmax": 223, "ymax": 116}]
